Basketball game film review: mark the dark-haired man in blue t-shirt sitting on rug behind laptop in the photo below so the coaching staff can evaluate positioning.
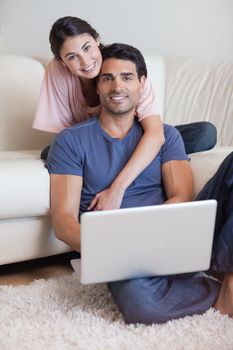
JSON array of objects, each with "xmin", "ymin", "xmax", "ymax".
[{"xmin": 47, "ymin": 44, "xmax": 233, "ymax": 324}]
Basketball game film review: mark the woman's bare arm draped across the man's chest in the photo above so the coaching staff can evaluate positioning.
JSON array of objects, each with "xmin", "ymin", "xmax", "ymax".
[{"xmin": 88, "ymin": 115, "xmax": 164, "ymax": 210}]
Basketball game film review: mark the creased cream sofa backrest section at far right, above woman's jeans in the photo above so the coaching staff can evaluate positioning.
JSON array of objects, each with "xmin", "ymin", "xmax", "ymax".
[{"xmin": 164, "ymin": 56, "xmax": 233, "ymax": 146}]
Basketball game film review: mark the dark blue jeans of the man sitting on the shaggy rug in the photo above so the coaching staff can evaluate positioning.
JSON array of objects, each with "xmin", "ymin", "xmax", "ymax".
[{"xmin": 108, "ymin": 152, "xmax": 233, "ymax": 324}]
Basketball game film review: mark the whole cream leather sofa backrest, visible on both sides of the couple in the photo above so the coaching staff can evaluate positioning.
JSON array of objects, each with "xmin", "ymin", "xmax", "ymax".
[{"xmin": 0, "ymin": 54, "xmax": 233, "ymax": 151}]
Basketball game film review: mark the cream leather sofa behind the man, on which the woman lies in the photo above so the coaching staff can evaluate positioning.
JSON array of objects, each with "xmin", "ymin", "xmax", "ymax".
[{"xmin": 0, "ymin": 54, "xmax": 233, "ymax": 265}]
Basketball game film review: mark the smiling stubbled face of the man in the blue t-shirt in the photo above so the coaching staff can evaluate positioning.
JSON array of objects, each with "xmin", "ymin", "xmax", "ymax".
[{"xmin": 97, "ymin": 58, "xmax": 145, "ymax": 115}]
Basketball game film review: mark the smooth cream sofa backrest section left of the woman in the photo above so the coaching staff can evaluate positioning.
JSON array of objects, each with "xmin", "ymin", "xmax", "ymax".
[{"xmin": 0, "ymin": 54, "xmax": 53, "ymax": 151}]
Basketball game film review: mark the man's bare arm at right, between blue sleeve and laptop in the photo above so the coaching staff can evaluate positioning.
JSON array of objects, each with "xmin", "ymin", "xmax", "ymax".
[{"xmin": 162, "ymin": 160, "xmax": 194, "ymax": 204}]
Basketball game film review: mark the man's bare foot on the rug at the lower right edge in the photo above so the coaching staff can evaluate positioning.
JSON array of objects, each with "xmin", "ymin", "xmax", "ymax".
[{"xmin": 214, "ymin": 273, "xmax": 233, "ymax": 317}]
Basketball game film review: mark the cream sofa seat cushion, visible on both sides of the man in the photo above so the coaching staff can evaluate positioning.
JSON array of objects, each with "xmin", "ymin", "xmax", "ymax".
[{"xmin": 0, "ymin": 147, "xmax": 233, "ymax": 219}]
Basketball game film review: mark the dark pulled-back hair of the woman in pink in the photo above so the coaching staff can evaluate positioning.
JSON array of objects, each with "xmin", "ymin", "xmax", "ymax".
[{"xmin": 49, "ymin": 16, "xmax": 102, "ymax": 60}]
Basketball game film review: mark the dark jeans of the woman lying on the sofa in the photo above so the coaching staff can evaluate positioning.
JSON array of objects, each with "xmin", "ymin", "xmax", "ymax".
[{"xmin": 40, "ymin": 122, "xmax": 217, "ymax": 160}]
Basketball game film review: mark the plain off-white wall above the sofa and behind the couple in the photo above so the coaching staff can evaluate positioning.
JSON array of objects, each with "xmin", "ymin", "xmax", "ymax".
[{"xmin": 0, "ymin": 0, "xmax": 233, "ymax": 56}]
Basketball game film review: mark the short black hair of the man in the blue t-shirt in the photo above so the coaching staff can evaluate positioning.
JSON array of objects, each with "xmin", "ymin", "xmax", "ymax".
[{"xmin": 101, "ymin": 43, "xmax": 147, "ymax": 79}]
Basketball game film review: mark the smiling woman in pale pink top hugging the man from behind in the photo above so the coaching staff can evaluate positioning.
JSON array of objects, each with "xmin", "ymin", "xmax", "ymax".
[{"xmin": 33, "ymin": 17, "xmax": 217, "ymax": 210}]
